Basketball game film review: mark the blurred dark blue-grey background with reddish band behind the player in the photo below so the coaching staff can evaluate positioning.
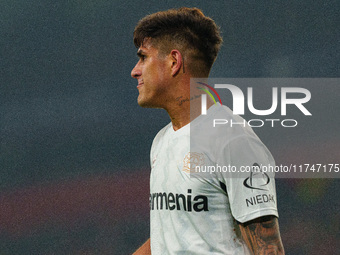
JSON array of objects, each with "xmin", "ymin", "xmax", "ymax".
[{"xmin": 0, "ymin": 0, "xmax": 340, "ymax": 255}]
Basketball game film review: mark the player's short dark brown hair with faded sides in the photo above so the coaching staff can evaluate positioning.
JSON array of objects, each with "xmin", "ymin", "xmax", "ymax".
[{"xmin": 133, "ymin": 7, "xmax": 222, "ymax": 76}]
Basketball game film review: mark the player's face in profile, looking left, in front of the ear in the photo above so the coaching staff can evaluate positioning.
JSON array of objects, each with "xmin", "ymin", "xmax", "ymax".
[{"xmin": 131, "ymin": 40, "xmax": 171, "ymax": 108}]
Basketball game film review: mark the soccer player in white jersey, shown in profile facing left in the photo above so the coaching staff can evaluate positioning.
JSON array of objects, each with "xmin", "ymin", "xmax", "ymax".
[{"xmin": 131, "ymin": 7, "xmax": 284, "ymax": 255}]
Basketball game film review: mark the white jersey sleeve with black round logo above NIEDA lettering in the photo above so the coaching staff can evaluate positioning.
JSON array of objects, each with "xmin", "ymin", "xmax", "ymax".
[{"xmin": 217, "ymin": 135, "xmax": 278, "ymax": 223}]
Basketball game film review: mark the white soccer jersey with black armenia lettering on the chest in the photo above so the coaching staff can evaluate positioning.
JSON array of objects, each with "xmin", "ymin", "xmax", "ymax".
[{"xmin": 150, "ymin": 105, "xmax": 278, "ymax": 255}]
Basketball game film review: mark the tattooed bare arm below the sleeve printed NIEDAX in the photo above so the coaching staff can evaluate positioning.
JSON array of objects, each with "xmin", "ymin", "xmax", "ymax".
[{"xmin": 239, "ymin": 216, "xmax": 284, "ymax": 255}]
